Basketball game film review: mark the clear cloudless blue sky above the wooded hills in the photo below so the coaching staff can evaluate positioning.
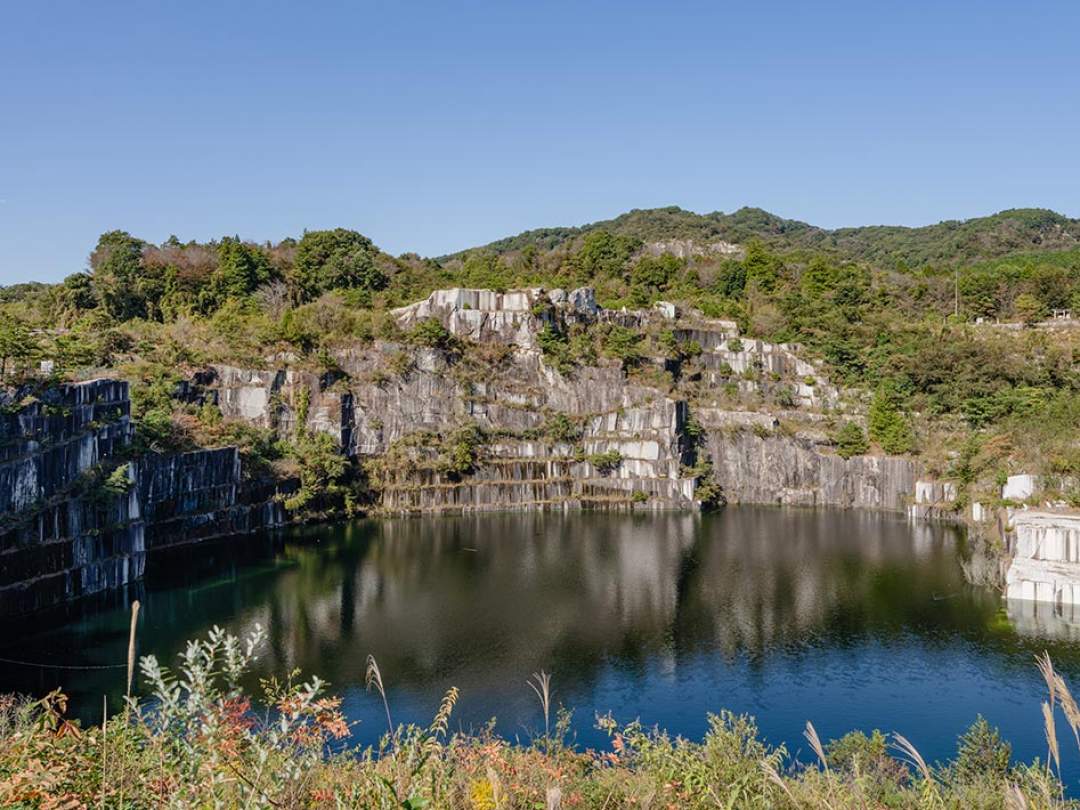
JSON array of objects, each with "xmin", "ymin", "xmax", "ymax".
[{"xmin": 0, "ymin": 0, "xmax": 1080, "ymax": 283}]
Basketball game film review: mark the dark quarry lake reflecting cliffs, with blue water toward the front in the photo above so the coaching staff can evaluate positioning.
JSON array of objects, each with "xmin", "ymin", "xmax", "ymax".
[{"xmin": 0, "ymin": 507, "xmax": 1080, "ymax": 770}]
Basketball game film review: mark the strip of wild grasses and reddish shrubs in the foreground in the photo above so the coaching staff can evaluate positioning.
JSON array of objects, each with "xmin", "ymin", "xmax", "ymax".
[{"xmin": 6, "ymin": 629, "xmax": 1080, "ymax": 810}]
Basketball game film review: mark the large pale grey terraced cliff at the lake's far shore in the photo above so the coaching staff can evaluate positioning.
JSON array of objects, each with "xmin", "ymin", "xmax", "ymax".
[{"xmin": 214, "ymin": 287, "xmax": 918, "ymax": 513}]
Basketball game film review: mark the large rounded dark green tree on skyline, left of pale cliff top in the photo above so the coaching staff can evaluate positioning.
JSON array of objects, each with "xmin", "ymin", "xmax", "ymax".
[{"xmin": 293, "ymin": 228, "xmax": 388, "ymax": 300}]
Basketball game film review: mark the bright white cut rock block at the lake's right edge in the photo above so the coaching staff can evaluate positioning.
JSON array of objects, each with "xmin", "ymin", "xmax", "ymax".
[{"xmin": 1005, "ymin": 511, "xmax": 1080, "ymax": 609}]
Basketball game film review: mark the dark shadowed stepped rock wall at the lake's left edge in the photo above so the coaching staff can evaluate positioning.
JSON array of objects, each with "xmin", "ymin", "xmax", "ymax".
[{"xmin": 0, "ymin": 380, "xmax": 284, "ymax": 616}]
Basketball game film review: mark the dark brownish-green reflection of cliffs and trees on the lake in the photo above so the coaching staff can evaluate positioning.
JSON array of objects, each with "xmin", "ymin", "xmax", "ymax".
[{"xmin": 0, "ymin": 507, "xmax": 997, "ymax": 721}]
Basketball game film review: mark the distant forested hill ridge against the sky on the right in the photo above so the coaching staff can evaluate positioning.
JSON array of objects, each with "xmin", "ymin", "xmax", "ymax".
[{"xmin": 459, "ymin": 206, "xmax": 1080, "ymax": 269}]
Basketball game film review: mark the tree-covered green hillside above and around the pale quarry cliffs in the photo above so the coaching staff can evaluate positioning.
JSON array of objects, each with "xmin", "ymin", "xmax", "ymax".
[{"xmin": 0, "ymin": 208, "xmax": 1080, "ymax": 520}]
